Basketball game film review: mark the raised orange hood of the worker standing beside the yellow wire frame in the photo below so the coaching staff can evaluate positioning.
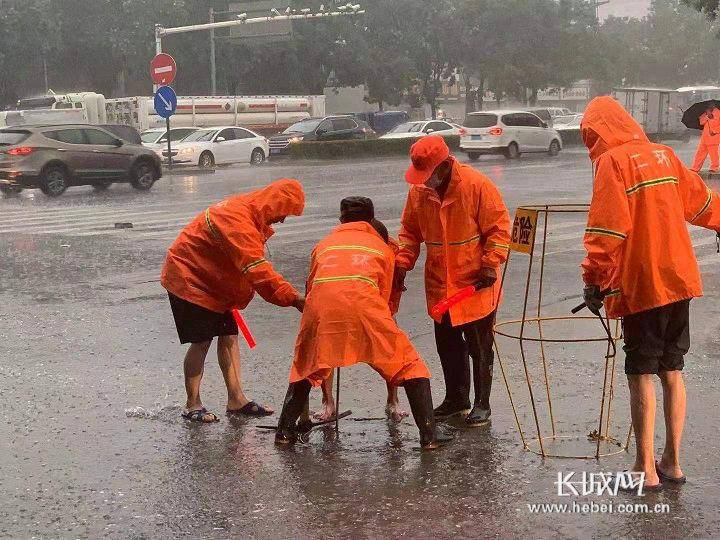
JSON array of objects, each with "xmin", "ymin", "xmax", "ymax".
[{"xmin": 580, "ymin": 96, "xmax": 649, "ymax": 162}]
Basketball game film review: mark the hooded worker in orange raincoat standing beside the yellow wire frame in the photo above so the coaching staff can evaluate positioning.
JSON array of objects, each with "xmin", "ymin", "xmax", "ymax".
[{"xmin": 581, "ymin": 97, "xmax": 720, "ymax": 490}]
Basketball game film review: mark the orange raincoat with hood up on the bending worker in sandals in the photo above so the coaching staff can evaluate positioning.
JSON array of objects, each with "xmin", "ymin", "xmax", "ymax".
[{"xmin": 161, "ymin": 180, "xmax": 305, "ymax": 313}]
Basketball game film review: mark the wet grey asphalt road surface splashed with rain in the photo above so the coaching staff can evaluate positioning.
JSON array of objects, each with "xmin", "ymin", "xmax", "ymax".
[{"xmin": 0, "ymin": 141, "xmax": 720, "ymax": 538}]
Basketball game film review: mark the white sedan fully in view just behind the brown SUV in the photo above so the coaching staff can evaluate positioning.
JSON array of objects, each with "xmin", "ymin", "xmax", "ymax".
[{"xmin": 162, "ymin": 126, "xmax": 270, "ymax": 169}]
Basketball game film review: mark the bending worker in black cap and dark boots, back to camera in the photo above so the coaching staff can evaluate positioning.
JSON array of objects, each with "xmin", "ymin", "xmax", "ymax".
[{"xmin": 275, "ymin": 197, "xmax": 450, "ymax": 449}]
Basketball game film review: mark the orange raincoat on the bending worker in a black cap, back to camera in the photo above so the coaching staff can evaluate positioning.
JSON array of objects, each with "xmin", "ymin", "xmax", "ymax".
[{"xmin": 290, "ymin": 222, "xmax": 430, "ymax": 386}]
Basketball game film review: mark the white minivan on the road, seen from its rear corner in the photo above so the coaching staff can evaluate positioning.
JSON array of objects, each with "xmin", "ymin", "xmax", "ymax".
[{"xmin": 460, "ymin": 110, "xmax": 562, "ymax": 161}]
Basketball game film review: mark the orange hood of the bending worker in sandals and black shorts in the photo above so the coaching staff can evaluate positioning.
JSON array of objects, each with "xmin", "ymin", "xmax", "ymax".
[{"xmin": 245, "ymin": 178, "xmax": 305, "ymax": 228}]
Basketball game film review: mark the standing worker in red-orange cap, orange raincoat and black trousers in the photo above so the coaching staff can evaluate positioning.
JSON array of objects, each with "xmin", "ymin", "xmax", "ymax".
[{"xmin": 394, "ymin": 136, "xmax": 510, "ymax": 426}]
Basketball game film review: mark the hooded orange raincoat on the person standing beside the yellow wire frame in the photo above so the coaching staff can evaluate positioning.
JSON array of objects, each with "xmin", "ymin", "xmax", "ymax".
[{"xmin": 581, "ymin": 97, "xmax": 720, "ymax": 317}]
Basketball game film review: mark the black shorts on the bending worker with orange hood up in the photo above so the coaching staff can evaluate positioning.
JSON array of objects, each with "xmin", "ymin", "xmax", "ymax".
[{"xmin": 168, "ymin": 292, "xmax": 238, "ymax": 343}]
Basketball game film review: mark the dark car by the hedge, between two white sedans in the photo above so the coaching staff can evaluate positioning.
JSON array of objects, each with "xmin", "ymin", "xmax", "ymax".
[{"xmin": 270, "ymin": 115, "xmax": 375, "ymax": 155}]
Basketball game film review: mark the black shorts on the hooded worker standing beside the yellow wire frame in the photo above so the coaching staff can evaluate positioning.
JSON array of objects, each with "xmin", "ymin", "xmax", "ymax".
[{"xmin": 623, "ymin": 300, "xmax": 690, "ymax": 375}]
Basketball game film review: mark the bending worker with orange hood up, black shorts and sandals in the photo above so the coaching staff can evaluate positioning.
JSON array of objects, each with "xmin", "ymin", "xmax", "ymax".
[{"xmin": 161, "ymin": 180, "xmax": 305, "ymax": 422}]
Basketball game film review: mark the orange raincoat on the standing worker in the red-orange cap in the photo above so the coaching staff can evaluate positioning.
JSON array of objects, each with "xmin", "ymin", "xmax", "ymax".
[{"xmin": 397, "ymin": 159, "xmax": 510, "ymax": 326}]
